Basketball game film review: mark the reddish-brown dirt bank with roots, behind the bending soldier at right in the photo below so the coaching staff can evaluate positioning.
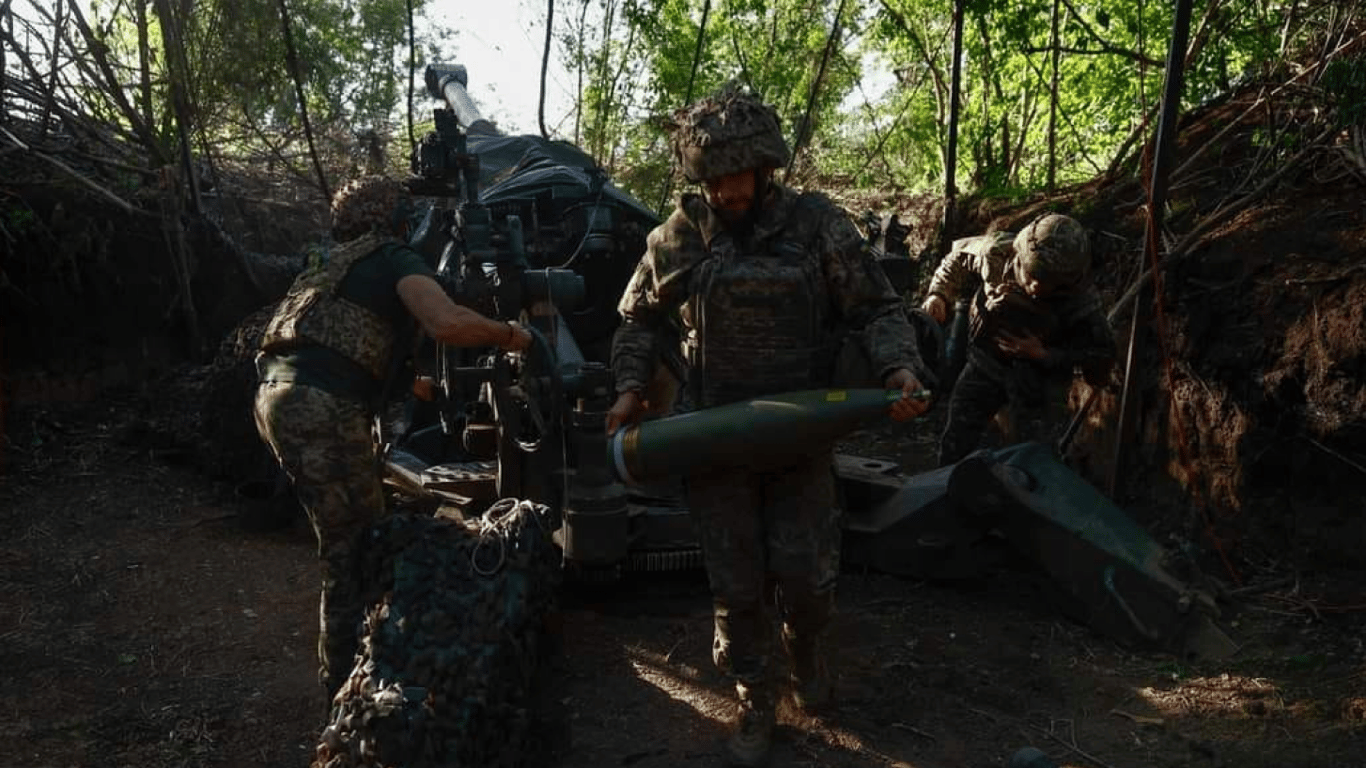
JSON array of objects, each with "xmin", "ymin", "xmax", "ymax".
[{"xmin": 1081, "ymin": 184, "xmax": 1366, "ymax": 567}]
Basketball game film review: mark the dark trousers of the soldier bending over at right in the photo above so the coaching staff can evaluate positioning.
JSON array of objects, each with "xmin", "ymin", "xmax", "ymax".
[{"xmin": 938, "ymin": 350, "xmax": 1065, "ymax": 466}]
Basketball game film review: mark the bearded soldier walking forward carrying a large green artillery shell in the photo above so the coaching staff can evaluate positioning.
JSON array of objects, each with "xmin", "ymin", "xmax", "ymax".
[{"xmin": 607, "ymin": 87, "xmax": 929, "ymax": 765}]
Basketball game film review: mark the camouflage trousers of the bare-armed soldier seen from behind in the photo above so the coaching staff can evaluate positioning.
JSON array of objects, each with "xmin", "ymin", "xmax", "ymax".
[{"xmin": 254, "ymin": 383, "xmax": 385, "ymax": 696}]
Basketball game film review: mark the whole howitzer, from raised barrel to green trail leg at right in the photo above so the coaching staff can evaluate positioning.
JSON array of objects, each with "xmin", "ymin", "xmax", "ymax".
[{"xmin": 385, "ymin": 64, "xmax": 1232, "ymax": 656}]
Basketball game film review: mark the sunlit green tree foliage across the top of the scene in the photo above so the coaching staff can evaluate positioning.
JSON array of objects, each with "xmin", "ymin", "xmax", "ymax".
[{"xmin": 0, "ymin": 0, "xmax": 1362, "ymax": 205}]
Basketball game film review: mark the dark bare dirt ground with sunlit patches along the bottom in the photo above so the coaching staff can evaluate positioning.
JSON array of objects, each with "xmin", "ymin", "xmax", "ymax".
[{"xmin": 0, "ymin": 400, "xmax": 1366, "ymax": 768}]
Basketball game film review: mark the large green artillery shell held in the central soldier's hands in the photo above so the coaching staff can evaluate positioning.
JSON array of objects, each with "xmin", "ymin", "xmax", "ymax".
[{"xmin": 608, "ymin": 389, "xmax": 902, "ymax": 485}]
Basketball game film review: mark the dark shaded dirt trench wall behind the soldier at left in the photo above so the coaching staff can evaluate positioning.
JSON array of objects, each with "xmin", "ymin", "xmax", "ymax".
[{"xmin": 0, "ymin": 183, "xmax": 311, "ymax": 403}]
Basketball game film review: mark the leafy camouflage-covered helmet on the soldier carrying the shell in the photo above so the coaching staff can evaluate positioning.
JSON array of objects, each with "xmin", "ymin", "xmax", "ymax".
[{"xmin": 672, "ymin": 85, "xmax": 790, "ymax": 182}]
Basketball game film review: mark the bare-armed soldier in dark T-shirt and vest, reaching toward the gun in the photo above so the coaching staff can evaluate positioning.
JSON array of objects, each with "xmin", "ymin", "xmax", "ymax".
[{"xmin": 254, "ymin": 176, "xmax": 531, "ymax": 698}]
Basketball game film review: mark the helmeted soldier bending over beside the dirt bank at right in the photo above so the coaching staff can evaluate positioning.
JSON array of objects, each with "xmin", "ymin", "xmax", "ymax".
[{"xmin": 922, "ymin": 213, "xmax": 1115, "ymax": 466}]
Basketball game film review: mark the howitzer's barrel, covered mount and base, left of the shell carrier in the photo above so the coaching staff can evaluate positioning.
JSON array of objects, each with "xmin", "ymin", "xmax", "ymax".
[{"xmin": 387, "ymin": 64, "xmax": 688, "ymax": 575}]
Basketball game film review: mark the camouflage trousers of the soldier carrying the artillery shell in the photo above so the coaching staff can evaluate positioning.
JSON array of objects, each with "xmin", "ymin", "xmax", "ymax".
[{"xmin": 684, "ymin": 451, "xmax": 840, "ymax": 697}]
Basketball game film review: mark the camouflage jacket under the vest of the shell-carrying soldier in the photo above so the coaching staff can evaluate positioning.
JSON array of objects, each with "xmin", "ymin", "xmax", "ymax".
[{"xmin": 612, "ymin": 184, "xmax": 926, "ymax": 392}]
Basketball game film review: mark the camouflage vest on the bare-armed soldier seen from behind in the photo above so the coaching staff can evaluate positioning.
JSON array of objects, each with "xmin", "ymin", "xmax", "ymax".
[{"xmin": 261, "ymin": 234, "xmax": 396, "ymax": 381}]
